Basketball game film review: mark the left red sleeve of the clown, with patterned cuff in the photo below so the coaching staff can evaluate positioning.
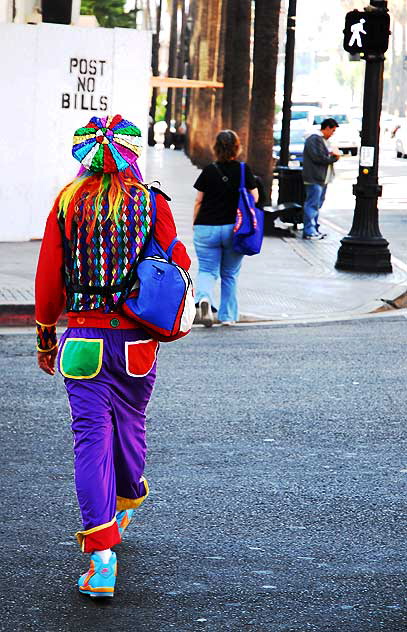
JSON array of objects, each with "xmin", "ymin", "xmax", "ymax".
[{"xmin": 35, "ymin": 203, "xmax": 65, "ymax": 351}]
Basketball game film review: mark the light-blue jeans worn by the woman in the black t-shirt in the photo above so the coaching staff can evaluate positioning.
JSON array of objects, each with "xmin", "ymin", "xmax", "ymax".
[{"xmin": 194, "ymin": 224, "xmax": 244, "ymax": 321}]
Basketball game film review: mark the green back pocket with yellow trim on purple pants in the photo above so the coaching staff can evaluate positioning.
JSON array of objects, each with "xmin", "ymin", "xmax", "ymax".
[{"xmin": 60, "ymin": 338, "xmax": 103, "ymax": 380}]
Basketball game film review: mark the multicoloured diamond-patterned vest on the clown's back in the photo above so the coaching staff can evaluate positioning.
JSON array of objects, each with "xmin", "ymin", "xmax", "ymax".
[{"xmin": 60, "ymin": 187, "xmax": 151, "ymax": 312}]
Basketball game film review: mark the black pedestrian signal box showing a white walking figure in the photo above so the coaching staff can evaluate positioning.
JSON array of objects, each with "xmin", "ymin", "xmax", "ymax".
[{"xmin": 343, "ymin": 9, "xmax": 390, "ymax": 55}]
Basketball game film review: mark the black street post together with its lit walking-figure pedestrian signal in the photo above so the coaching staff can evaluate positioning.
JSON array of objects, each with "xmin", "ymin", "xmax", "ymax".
[{"xmin": 335, "ymin": 0, "xmax": 392, "ymax": 273}]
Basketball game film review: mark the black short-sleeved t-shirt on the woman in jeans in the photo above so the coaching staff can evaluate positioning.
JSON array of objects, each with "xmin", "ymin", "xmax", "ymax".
[{"xmin": 194, "ymin": 160, "xmax": 257, "ymax": 226}]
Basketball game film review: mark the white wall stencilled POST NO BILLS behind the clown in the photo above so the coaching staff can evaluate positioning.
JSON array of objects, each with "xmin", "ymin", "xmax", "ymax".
[{"xmin": 0, "ymin": 24, "xmax": 151, "ymax": 241}]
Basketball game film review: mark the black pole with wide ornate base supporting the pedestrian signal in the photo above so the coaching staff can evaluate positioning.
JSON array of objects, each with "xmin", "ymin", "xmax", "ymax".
[{"xmin": 335, "ymin": 0, "xmax": 392, "ymax": 273}]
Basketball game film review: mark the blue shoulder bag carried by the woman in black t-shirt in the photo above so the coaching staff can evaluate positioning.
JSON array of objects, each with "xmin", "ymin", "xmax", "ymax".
[{"xmin": 232, "ymin": 162, "xmax": 264, "ymax": 255}]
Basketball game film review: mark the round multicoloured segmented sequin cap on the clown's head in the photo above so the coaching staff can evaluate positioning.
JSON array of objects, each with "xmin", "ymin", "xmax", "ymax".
[{"xmin": 72, "ymin": 114, "xmax": 142, "ymax": 173}]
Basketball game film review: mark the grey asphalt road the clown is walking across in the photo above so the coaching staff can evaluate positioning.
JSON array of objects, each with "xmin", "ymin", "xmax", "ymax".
[{"xmin": 0, "ymin": 315, "xmax": 407, "ymax": 632}]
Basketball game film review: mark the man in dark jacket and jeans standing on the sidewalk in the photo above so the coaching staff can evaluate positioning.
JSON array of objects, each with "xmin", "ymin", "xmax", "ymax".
[{"xmin": 302, "ymin": 118, "xmax": 340, "ymax": 240}]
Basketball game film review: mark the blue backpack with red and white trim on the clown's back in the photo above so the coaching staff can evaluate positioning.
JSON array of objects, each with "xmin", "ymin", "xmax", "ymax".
[{"xmin": 122, "ymin": 191, "xmax": 196, "ymax": 342}]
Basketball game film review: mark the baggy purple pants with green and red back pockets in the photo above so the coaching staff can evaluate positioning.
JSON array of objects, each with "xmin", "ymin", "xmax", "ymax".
[{"xmin": 58, "ymin": 327, "xmax": 158, "ymax": 552}]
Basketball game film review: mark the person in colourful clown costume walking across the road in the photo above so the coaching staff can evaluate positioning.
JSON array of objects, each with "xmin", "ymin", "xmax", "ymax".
[{"xmin": 35, "ymin": 115, "xmax": 190, "ymax": 597}]
